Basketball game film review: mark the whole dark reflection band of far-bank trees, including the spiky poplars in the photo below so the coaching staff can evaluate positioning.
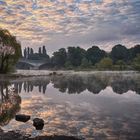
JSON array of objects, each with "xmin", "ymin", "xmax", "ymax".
[{"xmin": 13, "ymin": 75, "xmax": 140, "ymax": 94}]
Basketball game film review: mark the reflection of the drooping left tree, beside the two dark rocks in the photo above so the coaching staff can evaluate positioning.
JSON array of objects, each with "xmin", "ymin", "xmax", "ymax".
[{"xmin": 0, "ymin": 82, "xmax": 21, "ymax": 125}]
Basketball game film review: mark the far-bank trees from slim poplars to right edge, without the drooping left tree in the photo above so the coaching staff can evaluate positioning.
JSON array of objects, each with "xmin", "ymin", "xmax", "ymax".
[{"xmin": 21, "ymin": 44, "xmax": 140, "ymax": 70}]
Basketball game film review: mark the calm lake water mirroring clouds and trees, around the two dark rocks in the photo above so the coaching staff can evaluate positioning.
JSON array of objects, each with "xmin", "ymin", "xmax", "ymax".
[{"xmin": 0, "ymin": 72, "xmax": 140, "ymax": 140}]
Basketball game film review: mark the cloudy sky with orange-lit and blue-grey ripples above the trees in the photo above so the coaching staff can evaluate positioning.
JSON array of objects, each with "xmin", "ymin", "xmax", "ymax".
[{"xmin": 0, "ymin": 0, "xmax": 140, "ymax": 53}]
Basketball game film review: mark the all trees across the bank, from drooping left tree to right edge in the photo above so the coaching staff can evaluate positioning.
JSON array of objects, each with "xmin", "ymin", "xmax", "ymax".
[{"xmin": 0, "ymin": 29, "xmax": 140, "ymax": 73}]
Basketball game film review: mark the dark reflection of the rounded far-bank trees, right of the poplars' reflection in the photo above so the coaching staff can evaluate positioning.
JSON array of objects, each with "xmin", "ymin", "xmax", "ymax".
[{"xmin": 52, "ymin": 74, "xmax": 140, "ymax": 94}]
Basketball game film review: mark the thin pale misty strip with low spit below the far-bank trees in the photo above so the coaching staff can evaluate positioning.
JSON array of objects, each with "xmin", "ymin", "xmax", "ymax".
[{"xmin": 0, "ymin": 70, "xmax": 139, "ymax": 81}]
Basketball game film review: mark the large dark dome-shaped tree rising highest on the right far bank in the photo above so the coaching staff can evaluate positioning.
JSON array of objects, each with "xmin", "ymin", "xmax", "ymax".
[{"xmin": 110, "ymin": 44, "xmax": 129, "ymax": 63}]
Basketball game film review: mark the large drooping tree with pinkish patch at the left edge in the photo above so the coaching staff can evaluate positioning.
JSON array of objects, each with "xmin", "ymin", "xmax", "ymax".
[{"xmin": 0, "ymin": 29, "xmax": 22, "ymax": 73}]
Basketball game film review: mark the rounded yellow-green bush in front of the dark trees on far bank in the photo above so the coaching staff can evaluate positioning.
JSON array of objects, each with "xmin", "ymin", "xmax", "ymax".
[{"xmin": 96, "ymin": 57, "xmax": 113, "ymax": 70}]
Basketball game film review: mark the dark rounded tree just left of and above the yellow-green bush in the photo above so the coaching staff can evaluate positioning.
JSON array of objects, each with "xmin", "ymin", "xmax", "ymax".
[{"xmin": 86, "ymin": 46, "xmax": 106, "ymax": 65}]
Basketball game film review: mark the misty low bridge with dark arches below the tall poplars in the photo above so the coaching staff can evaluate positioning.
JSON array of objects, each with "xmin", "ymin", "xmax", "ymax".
[{"xmin": 17, "ymin": 58, "xmax": 49, "ymax": 70}]
